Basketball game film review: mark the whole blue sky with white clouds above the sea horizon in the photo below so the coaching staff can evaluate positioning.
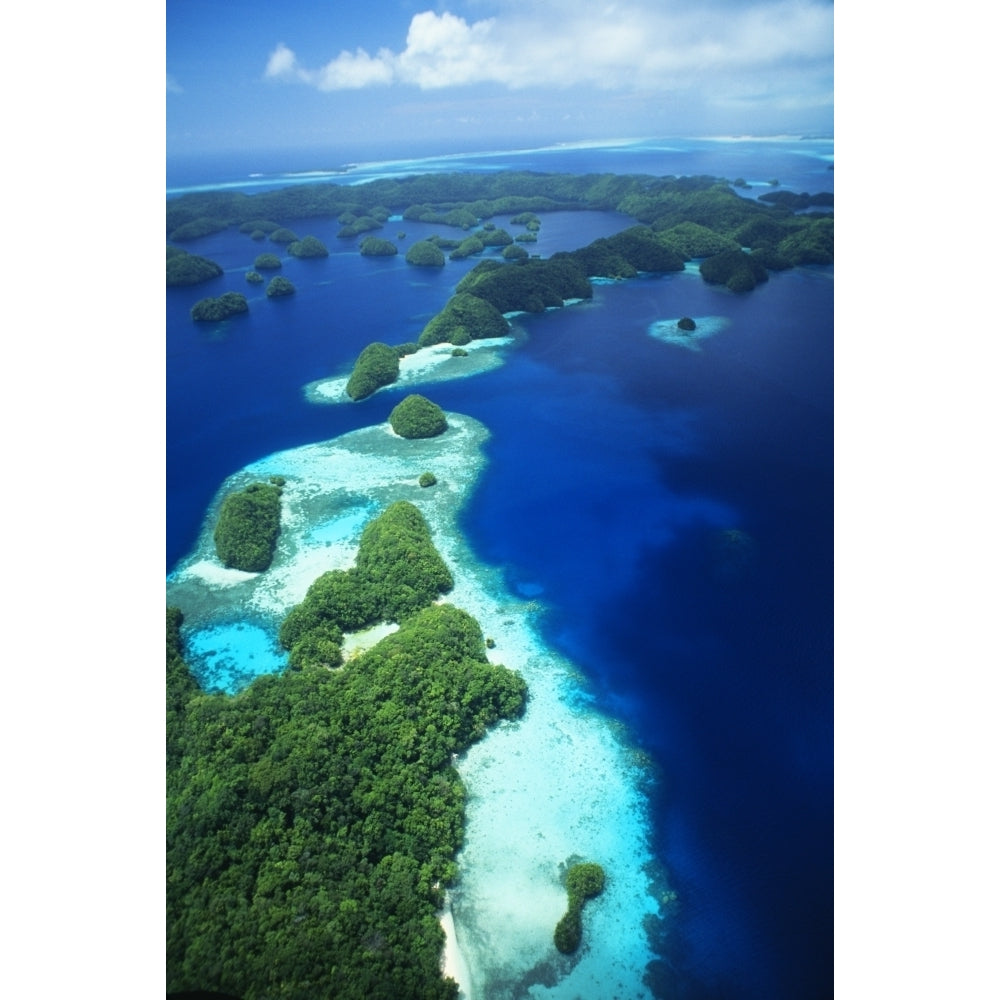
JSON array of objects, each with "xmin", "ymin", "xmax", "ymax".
[{"xmin": 166, "ymin": 0, "xmax": 833, "ymax": 158}]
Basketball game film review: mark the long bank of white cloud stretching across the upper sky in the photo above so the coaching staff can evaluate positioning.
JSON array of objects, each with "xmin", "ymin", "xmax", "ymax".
[{"xmin": 266, "ymin": 0, "xmax": 833, "ymax": 106}]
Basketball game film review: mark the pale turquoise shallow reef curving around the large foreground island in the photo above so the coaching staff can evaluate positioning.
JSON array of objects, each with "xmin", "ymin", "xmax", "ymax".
[{"xmin": 167, "ymin": 413, "xmax": 665, "ymax": 1000}]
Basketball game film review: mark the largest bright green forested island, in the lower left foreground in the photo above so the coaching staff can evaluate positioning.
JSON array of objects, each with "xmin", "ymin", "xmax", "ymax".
[{"xmin": 166, "ymin": 502, "xmax": 526, "ymax": 1000}]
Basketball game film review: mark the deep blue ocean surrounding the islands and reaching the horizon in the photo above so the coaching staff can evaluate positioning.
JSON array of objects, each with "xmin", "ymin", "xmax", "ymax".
[{"xmin": 166, "ymin": 139, "xmax": 834, "ymax": 1000}]
